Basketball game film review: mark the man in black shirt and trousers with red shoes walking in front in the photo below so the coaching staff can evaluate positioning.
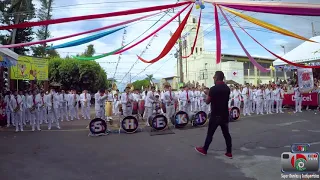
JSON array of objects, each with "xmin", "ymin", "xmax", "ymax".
[{"xmin": 195, "ymin": 71, "xmax": 232, "ymax": 158}]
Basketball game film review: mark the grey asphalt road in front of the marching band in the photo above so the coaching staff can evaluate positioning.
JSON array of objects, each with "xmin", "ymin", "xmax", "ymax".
[{"xmin": 0, "ymin": 109, "xmax": 320, "ymax": 180}]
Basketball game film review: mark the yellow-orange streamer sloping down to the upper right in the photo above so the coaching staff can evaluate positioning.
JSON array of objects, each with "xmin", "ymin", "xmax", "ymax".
[{"xmin": 222, "ymin": 7, "xmax": 315, "ymax": 42}]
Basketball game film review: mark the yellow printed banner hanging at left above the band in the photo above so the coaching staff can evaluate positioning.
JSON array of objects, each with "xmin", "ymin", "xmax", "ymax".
[{"xmin": 10, "ymin": 56, "xmax": 48, "ymax": 81}]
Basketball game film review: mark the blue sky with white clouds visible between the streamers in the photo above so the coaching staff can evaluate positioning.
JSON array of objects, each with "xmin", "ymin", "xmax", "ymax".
[{"xmin": 28, "ymin": 0, "xmax": 320, "ymax": 89}]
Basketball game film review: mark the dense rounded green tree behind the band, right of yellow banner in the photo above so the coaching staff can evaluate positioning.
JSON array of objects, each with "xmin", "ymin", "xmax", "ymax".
[{"xmin": 49, "ymin": 58, "xmax": 107, "ymax": 92}]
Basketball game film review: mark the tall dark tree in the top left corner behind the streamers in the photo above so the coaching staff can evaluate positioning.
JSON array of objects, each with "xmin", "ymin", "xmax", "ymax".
[{"xmin": 0, "ymin": 0, "xmax": 35, "ymax": 55}]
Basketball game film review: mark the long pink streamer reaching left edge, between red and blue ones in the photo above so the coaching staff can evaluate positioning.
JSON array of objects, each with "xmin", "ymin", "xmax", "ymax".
[{"xmin": 0, "ymin": 12, "xmax": 161, "ymax": 48}]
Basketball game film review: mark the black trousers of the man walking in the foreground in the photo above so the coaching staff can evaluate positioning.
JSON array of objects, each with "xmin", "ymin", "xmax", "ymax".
[{"xmin": 203, "ymin": 116, "xmax": 232, "ymax": 153}]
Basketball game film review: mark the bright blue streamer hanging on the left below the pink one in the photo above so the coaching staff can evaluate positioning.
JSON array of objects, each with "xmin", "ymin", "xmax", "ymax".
[{"xmin": 47, "ymin": 26, "xmax": 126, "ymax": 50}]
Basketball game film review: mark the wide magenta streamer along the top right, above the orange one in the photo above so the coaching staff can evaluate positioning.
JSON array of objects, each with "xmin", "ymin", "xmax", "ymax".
[{"xmin": 216, "ymin": 0, "xmax": 320, "ymax": 16}]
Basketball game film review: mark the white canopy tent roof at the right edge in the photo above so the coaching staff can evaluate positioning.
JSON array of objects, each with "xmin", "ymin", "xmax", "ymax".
[{"xmin": 273, "ymin": 36, "xmax": 320, "ymax": 66}]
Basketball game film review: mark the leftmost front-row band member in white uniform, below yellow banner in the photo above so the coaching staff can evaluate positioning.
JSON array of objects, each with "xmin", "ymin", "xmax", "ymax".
[{"xmin": 10, "ymin": 91, "xmax": 23, "ymax": 132}]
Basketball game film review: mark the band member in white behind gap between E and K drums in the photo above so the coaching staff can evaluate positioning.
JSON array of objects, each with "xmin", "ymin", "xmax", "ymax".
[{"xmin": 163, "ymin": 85, "xmax": 176, "ymax": 119}]
